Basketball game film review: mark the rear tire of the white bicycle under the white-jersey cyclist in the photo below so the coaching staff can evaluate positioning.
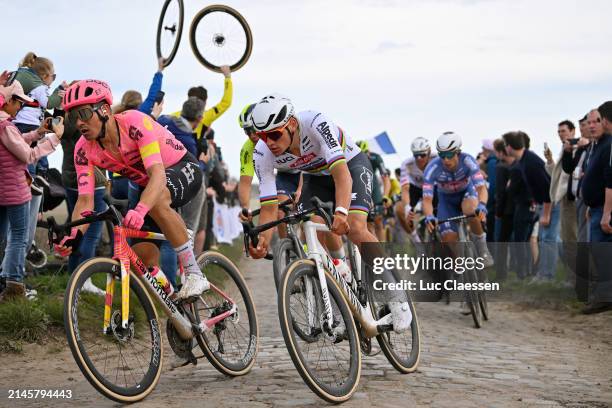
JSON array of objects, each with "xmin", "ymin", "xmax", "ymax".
[{"xmin": 366, "ymin": 266, "xmax": 421, "ymax": 374}]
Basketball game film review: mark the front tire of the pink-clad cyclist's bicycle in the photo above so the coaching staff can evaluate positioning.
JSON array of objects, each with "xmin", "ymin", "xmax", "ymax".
[{"xmin": 64, "ymin": 258, "xmax": 163, "ymax": 403}]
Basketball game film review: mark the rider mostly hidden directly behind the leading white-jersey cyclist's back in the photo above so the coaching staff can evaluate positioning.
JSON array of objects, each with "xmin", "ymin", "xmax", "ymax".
[{"xmin": 357, "ymin": 140, "xmax": 391, "ymax": 242}]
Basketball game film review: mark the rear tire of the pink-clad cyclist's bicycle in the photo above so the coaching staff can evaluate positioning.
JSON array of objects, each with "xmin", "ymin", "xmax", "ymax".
[{"xmin": 191, "ymin": 251, "xmax": 259, "ymax": 377}]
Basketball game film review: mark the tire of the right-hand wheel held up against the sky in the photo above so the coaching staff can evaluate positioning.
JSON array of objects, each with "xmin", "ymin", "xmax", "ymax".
[{"xmin": 189, "ymin": 4, "xmax": 253, "ymax": 72}]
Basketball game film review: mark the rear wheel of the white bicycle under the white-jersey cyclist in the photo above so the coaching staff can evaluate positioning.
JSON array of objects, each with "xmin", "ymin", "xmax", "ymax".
[{"xmin": 365, "ymin": 271, "xmax": 421, "ymax": 374}]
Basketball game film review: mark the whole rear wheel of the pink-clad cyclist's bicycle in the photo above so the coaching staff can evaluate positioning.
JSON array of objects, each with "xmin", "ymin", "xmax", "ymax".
[{"xmin": 191, "ymin": 251, "xmax": 259, "ymax": 376}]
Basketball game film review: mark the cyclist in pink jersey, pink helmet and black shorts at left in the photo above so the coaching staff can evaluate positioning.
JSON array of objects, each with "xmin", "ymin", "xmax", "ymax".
[{"xmin": 56, "ymin": 80, "xmax": 209, "ymax": 299}]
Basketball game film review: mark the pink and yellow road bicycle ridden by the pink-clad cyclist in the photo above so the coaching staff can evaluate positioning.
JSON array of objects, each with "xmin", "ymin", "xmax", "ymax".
[{"xmin": 47, "ymin": 205, "xmax": 258, "ymax": 402}]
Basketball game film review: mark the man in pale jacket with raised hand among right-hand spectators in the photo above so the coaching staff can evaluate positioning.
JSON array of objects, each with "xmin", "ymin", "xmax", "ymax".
[{"xmin": 544, "ymin": 120, "xmax": 578, "ymax": 287}]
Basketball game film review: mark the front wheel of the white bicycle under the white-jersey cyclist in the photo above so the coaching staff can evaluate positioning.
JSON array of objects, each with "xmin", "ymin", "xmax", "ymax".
[{"xmin": 278, "ymin": 259, "xmax": 361, "ymax": 403}]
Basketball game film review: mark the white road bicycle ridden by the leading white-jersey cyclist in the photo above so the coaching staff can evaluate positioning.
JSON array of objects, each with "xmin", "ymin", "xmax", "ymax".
[{"xmin": 245, "ymin": 197, "xmax": 420, "ymax": 403}]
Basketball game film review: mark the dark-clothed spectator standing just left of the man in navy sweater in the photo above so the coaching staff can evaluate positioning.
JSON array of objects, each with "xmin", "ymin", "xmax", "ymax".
[{"xmin": 493, "ymin": 139, "xmax": 515, "ymax": 281}]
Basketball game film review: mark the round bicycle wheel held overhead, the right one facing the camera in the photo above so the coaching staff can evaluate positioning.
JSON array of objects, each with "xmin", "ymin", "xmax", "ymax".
[{"xmin": 189, "ymin": 4, "xmax": 253, "ymax": 72}]
